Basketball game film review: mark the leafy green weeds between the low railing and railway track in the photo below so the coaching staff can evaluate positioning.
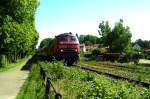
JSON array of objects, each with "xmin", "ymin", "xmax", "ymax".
[{"xmin": 43, "ymin": 62, "xmax": 147, "ymax": 99}]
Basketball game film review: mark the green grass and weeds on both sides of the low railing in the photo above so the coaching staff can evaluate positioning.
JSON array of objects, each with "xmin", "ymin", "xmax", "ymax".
[{"xmin": 16, "ymin": 62, "xmax": 150, "ymax": 99}]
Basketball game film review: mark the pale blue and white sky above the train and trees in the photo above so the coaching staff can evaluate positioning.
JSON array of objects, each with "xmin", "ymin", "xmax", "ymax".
[{"xmin": 35, "ymin": 0, "xmax": 150, "ymax": 42}]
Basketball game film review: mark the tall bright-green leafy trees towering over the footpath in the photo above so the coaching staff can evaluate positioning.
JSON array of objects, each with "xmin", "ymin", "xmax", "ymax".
[{"xmin": 0, "ymin": 0, "xmax": 39, "ymax": 66}]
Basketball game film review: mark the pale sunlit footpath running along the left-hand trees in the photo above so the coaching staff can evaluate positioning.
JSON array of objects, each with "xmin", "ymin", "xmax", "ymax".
[{"xmin": 0, "ymin": 63, "xmax": 29, "ymax": 99}]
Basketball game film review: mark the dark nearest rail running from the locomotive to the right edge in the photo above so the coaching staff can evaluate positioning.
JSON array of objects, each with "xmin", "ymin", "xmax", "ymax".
[{"xmin": 77, "ymin": 64, "xmax": 150, "ymax": 88}]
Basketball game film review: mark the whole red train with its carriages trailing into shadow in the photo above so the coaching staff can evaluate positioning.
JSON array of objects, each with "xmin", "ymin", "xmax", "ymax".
[{"xmin": 40, "ymin": 33, "xmax": 80, "ymax": 65}]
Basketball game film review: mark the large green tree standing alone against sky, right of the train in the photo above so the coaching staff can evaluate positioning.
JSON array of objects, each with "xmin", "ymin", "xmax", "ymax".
[{"xmin": 99, "ymin": 19, "xmax": 132, "ymax": 53}]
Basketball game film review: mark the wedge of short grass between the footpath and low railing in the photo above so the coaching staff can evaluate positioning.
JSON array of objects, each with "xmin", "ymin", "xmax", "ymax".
[{"xmin": 16, "ymin": 64, "xmax": 45, "ymax": 99}]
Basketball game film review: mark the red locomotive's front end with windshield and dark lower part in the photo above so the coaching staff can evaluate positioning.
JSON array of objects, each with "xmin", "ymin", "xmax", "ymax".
[{"xmin": 55, "ymin": 33, "xmax": 80, "ymax": 65}]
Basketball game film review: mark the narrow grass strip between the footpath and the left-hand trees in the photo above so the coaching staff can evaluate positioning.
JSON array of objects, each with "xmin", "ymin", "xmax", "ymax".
[{"xmin": 0, "ymin": 57, "xmax": 30, "ymax": 72}]
